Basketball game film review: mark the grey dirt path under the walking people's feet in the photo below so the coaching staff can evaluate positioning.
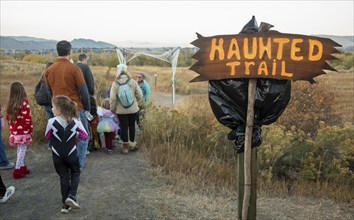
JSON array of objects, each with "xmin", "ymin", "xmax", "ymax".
[{"xmin": 0, "ymin": 146, "xmax": 163, "ymax": 220}]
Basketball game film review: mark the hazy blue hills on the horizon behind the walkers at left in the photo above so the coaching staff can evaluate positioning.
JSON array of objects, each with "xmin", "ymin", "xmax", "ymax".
[{"xmin": 0, "ymin": 36, "xmax": 116, "ymax": 50}]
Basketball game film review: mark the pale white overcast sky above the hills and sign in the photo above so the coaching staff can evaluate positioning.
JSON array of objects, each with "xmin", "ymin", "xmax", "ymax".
[{"xmin": 0, "ymin": 0, "xmax": 354, "ymax": 47}]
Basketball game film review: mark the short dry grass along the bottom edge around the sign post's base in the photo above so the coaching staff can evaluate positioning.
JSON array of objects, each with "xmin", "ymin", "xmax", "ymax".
[{"xmin": 141, "ymin": 180, "xmax": 354, "ymax": 220}]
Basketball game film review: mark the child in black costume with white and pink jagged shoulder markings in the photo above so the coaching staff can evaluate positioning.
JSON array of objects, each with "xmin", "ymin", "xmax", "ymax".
[{"xmin": 45, "ymin": 95, "xmax": 88, "ymax": 213}]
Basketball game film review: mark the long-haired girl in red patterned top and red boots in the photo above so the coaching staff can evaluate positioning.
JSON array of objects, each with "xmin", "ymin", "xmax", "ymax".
[{"xmin": 6, "ymin": 82, "xmax": 33, "ymax": 179}]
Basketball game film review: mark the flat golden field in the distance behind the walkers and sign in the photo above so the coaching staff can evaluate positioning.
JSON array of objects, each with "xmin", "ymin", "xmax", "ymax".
[{"xmin": 0, "ymin": 60, "xmax": 354, "ymax": 118}]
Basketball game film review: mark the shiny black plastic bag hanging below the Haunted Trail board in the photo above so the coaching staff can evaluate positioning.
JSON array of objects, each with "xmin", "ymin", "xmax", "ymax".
[{"xmin": 208, "ymin": 79, "xmax": 291, "ymax": 153}]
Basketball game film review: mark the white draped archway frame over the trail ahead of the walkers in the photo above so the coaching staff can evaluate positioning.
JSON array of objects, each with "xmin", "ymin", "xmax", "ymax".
[{"xmin": 116, "ymin": 47, "xmax": 181, "ymax": 106}]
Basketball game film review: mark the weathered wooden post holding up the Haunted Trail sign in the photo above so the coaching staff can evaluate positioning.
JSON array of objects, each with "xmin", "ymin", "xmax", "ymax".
[{"xmin": 238, "ymin": 79, "xmax": 257, "ymax": 220}]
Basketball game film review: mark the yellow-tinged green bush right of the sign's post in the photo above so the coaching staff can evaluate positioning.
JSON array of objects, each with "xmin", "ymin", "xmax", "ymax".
[{"xmin": 258, "ymin": 122, "xmax": 354, "ymax": 184}]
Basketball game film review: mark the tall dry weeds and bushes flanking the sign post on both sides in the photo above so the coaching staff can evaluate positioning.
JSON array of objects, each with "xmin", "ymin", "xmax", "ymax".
[{"xmin": 139, "ymin": 95, "xmax": 354, "ymax": 201}]
